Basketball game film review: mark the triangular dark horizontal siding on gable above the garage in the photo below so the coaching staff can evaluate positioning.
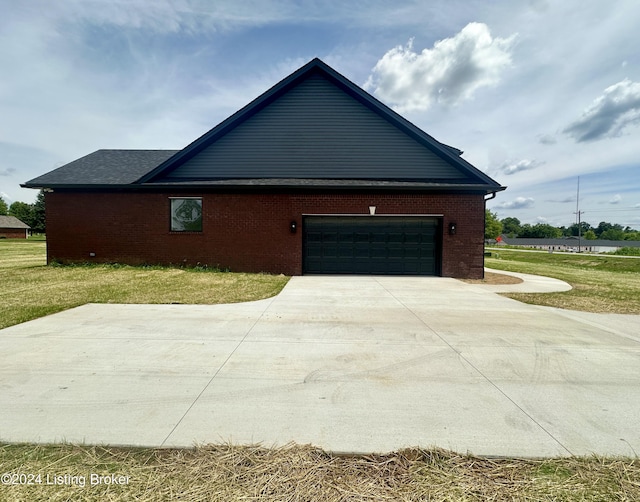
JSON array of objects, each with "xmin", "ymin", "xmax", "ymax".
[{"xmin": 166, "ymin": 75, "xmax": 465, "ymax": 181}]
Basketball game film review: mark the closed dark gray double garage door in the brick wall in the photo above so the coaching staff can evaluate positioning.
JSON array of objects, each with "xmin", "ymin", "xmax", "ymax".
[{"xmin": 302, "ymin": 216, "xmax": 441, "ymax": 275}]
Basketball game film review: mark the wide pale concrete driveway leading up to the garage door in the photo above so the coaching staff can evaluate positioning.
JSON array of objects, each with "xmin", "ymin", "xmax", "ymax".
[{"xmin": 0, "ymin": 276, "xmax": 640, "ymax": 457}]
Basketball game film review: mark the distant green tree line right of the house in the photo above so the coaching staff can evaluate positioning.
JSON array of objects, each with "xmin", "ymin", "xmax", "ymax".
[{"xmin": 485, "ymin": 209, "xmax": 640, "ymax": 241}]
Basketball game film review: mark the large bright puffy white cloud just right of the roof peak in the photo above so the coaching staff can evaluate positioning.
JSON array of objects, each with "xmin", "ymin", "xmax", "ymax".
[{"xmin": 365, "ymin": 23, "xmax": 515, "ymax": 112}]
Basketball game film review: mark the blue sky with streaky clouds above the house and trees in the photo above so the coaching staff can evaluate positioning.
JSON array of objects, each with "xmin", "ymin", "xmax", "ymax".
[{"xmin": 0, "ymin": 0, "xmax": 640, "ymax": 228}]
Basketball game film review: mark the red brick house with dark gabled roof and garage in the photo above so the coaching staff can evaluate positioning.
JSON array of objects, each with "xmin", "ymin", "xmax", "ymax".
[{"xmin": 23, "ymin": 59, "xmax": 505, "ymax": 278}]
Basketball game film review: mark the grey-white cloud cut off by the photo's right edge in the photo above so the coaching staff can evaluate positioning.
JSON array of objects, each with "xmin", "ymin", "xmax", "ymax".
[{"xmin": 563, "ymin": 78, "xmax": 640, "ymax": 142}]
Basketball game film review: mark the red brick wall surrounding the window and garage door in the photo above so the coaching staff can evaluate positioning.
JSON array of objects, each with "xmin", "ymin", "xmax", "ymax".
[{"xmin": 46, "ymin": 192, "xmax": 484, "ymax": 278}]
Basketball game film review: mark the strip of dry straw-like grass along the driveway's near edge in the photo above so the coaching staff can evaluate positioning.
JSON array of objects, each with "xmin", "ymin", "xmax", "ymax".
[{"xmin": 0, "ymin": 444, "xmax": 640, "ymax": 501}]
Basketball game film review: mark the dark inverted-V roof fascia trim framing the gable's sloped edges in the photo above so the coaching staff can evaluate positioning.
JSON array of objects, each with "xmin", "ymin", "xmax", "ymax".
[{"xmin": 135, "ymin": 58, "xmax": 506, "ymax": 193}]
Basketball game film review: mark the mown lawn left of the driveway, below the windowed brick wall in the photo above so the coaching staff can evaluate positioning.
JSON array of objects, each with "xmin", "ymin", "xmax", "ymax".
[{"xmin": 0, "ymin": 239, "xmax": 288, "ymax": 329}]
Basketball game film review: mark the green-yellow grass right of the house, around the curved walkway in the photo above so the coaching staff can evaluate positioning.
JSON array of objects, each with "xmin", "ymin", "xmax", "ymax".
[{"xmin": 485, "ymin": 250, "xmax": 640, "ymax": 314}]
